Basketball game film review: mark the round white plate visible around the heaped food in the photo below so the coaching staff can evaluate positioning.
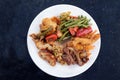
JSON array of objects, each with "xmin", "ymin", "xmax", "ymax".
[{"xmin": 27, "ymin": 4, "xmax": 101, "ymax": 78}]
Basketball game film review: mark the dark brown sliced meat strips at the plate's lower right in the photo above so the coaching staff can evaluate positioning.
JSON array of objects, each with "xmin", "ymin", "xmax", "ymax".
[{"xmin": 62, "ymin": 47, "xmax": 89, "ymax": 66}]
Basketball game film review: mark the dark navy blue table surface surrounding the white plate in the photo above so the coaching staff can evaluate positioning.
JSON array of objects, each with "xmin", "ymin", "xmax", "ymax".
[{"xmin": 0, "ymin": 0, "xmax": 120, "ymax": 80}]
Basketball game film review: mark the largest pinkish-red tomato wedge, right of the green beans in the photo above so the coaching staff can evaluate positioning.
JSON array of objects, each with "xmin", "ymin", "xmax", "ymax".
[{"xmin": 76, "ymin": 27, "xmax": 92, "ymax": 37}]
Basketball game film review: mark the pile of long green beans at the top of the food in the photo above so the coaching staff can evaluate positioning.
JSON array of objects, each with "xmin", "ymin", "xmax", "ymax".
[{"xmin": 58, "ymin": 15, "xmax": 90, "ymax": 41}]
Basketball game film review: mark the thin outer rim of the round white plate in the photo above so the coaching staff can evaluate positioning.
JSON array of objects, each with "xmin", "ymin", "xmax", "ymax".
[{"xmin": 27, "ymin": 4, "xmax": 101, "ymax": 78}]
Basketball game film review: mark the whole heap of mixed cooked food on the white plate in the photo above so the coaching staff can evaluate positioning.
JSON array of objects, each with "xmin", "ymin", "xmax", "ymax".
[{"xmin": 30, "ymin": 11, "xmax": 100, "ymax": 66}]
